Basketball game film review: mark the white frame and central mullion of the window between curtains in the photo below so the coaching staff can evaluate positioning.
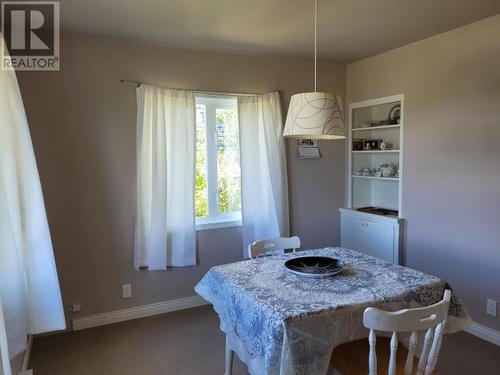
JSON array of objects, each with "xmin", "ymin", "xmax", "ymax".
[{"xmin": 195, "ymin": 94, "xmax": 242, "ymax": 231}]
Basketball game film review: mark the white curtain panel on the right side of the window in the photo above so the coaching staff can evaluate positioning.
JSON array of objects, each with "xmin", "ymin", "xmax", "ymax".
[{"xmin": 238, "ymin": 92, "xmax": 289, "ymax": 257}]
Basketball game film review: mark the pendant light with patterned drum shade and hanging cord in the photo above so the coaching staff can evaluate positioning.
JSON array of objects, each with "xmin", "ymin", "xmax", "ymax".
[{"xmin": 283, "ymin": 0, "xmax": 345, "ymax": 139}]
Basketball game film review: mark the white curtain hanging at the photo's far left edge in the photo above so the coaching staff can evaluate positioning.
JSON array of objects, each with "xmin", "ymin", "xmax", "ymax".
[{"xmin": 0, "ymin": 34, "xmax": 66, "ymax": 358}]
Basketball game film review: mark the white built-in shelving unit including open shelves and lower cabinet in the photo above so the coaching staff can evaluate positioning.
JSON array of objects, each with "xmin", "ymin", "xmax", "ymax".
[{"xmin": 340, "ymin": 95, "xmax": 404, "ymax": 264}]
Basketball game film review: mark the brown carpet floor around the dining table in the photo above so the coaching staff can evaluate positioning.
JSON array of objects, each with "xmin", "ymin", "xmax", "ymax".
[{"xmin": 30, "ymin": 306, "xmax": 500, "ymax": 375}]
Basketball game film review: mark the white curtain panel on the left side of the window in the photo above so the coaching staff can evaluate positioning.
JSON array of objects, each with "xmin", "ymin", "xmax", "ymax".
[{"xmin": 134, "ymin": 85, "xmax": 196, "ymax": 270}]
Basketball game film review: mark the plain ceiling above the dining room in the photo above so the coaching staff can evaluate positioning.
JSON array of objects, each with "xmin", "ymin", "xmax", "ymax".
[{"xmin": 61, "ymin": 0, "xmax": 500, "ymax": 62}]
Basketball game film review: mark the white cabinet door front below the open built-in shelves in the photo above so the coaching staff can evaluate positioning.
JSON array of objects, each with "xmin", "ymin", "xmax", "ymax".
[{"xmin": 341, "ymin": 215, "xmax": 398, "ymax": 263}]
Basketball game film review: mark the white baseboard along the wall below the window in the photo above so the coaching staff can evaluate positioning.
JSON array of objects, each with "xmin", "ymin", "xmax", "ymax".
[{"xmin": 72, "ymin": 296, "xmax": 208, "ymax": 331}]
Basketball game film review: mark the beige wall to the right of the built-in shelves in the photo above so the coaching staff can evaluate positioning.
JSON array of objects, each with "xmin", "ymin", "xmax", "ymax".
[{"xmin": 347, "ymin": 15, "xmax": 500, "ymax": 330}]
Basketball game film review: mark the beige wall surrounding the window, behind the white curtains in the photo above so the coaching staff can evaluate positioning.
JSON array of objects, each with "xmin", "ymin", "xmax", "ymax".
[{"xmin": 14, "ymin": 36, "xmax": 345, "ymax": 324}]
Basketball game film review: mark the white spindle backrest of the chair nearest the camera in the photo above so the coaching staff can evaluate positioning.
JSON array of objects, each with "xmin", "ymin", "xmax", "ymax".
[{"xmin": 363, "ymin": 289, "xmax": 451, "ymax": 375}]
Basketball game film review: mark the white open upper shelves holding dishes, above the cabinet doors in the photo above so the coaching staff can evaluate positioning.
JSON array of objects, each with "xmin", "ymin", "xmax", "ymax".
[{"xmin": 348, "ymin": 95, "xmax": 404, "ymax": 217}]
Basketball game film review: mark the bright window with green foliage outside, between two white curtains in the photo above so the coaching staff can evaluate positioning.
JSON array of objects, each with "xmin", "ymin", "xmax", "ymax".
[{"xmin": 195, "ymin": 95, "xmax": 241, "ymax": 229}]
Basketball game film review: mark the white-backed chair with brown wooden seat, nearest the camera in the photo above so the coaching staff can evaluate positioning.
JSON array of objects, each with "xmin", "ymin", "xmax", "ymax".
[{"xmin": 332, "ymin": 290, "xmax": 451, "ymax": 375}]
